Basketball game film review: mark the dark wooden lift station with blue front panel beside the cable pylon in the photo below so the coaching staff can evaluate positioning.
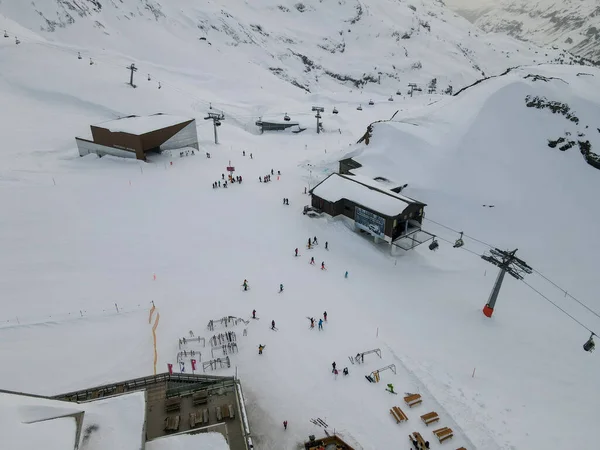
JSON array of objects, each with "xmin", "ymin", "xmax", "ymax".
[{"xmin": 310, "ymin": 173, "xmax": 426, "ymax": 243}]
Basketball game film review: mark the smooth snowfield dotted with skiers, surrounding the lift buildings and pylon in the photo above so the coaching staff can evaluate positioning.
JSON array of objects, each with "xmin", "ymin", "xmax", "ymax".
[{"xmin": 0, "ymin": 0, "xmax": 600, "ymax": 450}]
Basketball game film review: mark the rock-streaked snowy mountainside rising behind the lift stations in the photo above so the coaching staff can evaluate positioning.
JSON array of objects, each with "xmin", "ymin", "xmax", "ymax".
[{"xmin": 0, "ymin": 0, "xmax": 580, "ymax": 95}]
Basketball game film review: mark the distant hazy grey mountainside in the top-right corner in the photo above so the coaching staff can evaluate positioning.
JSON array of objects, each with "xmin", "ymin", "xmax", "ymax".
[{"xmin": 448, "ymin": 0, "xmax": 600, "ymax": 62}]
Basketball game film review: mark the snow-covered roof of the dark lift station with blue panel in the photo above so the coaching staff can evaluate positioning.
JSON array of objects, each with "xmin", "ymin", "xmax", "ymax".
[{"xmin": 311, "ymin": 173, "xmax": 415, "ymax": 217}]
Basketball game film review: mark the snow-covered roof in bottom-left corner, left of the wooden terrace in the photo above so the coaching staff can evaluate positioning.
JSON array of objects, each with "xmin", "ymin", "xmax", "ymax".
[{"xmin": 0, "ymin": 391, "xmax": 146, "ymax": 450}]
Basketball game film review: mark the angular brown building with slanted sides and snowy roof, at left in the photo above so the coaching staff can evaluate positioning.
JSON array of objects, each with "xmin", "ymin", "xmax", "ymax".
[{"xmin": 75, "ymin": 113, "xmax": 198, "ymax": 161}]
